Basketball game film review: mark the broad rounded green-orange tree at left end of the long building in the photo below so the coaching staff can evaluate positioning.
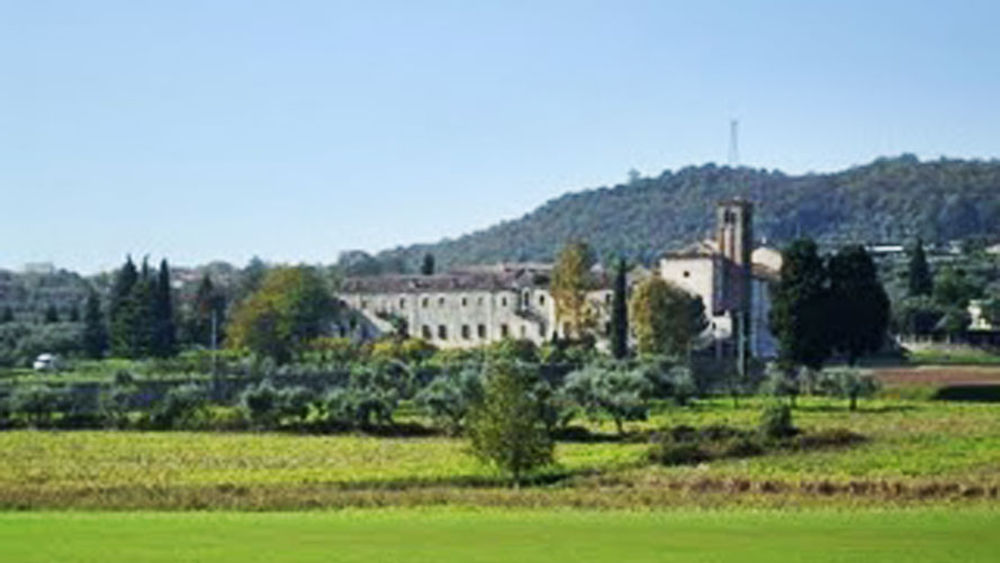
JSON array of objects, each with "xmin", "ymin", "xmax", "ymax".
[{"xmin": 227, "ymin": 266, "xmax": 336, "ymax": 363}]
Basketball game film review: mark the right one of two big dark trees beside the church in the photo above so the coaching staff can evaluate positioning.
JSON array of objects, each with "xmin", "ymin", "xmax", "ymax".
[{"xmin": 828, "ymin": 245, "xmax": 889, "ymax": 366}]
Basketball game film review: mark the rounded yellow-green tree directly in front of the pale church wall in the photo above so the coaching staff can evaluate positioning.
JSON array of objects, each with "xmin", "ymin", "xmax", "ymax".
[{"xmin": 629, "ymin": 277, "xmax": 708, "ymax": 357}]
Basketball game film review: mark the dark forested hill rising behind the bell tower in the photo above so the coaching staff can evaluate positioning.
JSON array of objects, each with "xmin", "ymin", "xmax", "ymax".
[{"xmin": 378, "ymin": 155, "xmax": 1000, "ymax": 270}]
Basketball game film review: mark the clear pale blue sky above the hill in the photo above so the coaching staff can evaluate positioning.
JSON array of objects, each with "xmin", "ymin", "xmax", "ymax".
[{"xmin": 0, "ymin": 0, "xmax": 1000, "ymax": 272}]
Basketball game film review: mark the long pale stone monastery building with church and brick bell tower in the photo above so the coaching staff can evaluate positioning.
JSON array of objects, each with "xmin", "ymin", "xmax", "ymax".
[{"xmin": 339, "ymin": 200, "xmax": 781, "ymax": 358}]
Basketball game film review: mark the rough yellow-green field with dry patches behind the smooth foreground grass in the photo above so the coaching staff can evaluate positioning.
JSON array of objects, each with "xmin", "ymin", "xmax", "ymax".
[{"xmin": 0, "ymin": 398, "xmax": 1000, "ymax": 510}]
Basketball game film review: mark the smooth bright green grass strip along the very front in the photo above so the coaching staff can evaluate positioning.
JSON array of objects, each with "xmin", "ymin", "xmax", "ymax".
[{"xmin": 0, "ymin": 509, "xmax": 1000, "ymax": 563}]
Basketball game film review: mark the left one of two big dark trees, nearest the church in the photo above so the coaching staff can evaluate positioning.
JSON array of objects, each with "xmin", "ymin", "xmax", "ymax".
[{"xmin": 769, "ymin": 239, "xmax": 832, "ymax": 369}]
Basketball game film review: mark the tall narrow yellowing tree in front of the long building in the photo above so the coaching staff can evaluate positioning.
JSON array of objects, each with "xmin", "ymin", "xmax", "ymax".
[{"xmin": 550, "ymin": 241, "xmax": 596, "ymax": 339}]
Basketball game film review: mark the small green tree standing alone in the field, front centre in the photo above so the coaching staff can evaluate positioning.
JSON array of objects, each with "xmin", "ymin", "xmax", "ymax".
[{"xmin": 468, "ymin": 362, "xmax": 555, "ymax": 485}]
